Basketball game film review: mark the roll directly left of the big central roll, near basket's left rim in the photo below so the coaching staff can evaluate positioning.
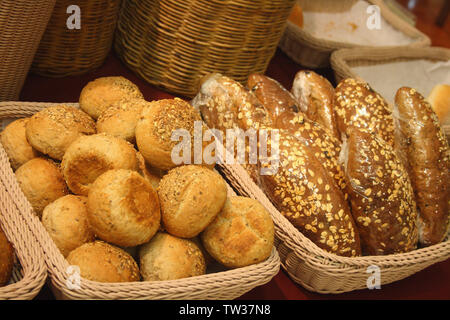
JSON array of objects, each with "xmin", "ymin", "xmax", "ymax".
[{"xmin": 42, "ymin": 195, "xmax": 95, "ymax": 257}]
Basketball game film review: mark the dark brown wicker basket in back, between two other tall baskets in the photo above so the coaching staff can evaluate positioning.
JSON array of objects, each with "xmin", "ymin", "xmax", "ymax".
[{"xmin": 31, "ymin": 0, "xmax": 121, "ymax": 77}]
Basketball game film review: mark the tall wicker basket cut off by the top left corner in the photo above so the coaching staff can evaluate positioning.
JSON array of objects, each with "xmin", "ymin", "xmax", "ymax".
[{"xmin": 0, "ymin": 0, "xmax": 55, "ymax": 101}]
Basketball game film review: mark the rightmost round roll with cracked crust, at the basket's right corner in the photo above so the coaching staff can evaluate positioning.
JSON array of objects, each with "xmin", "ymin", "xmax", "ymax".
[{"xmin": 201, "ymin": 196, "xmax": 274, "ymax": 268}]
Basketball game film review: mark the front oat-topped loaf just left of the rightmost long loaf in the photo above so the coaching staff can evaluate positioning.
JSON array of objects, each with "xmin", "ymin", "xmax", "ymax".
[{"xmin": 341, "ymin": 130, "xmax": 418, "ymax": 255}]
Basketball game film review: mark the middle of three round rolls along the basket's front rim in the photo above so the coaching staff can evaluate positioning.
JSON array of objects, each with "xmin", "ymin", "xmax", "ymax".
[{"xmin": 139, "ymin": 232, "xmax": 206, "ymax": 281}]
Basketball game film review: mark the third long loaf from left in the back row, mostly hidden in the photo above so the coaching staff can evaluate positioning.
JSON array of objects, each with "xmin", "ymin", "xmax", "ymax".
[{"xmin": 291, "ymin": 70, "xmax": 340, "ymax": 139}]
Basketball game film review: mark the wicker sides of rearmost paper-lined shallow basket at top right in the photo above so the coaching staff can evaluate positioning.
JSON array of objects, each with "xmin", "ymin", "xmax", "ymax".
[{"xmin": 279, "ymin": 0, "xmax": 431, "ymax": 68}]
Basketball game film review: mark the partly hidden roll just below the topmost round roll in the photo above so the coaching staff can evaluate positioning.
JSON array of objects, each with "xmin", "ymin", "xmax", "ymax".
[{"xmin": 97, "ymin": 99, "xmax": 149, "ymax": 143}]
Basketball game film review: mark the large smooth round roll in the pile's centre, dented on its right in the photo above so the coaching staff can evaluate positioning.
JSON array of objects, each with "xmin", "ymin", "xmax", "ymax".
[{"xmin": 87, "ymin": 169, "xmax": 161, "ymax": 247}]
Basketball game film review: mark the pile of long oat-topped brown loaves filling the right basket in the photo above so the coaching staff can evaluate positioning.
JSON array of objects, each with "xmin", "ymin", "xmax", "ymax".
[{"xmin": 192, "ymin": 70, "xmax": 450, "ymax": 257}]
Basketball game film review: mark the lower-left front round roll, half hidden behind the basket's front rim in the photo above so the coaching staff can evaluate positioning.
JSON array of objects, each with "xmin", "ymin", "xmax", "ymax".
[{"xmin": 67, "ymin": 241, "xmax": 140, "ymax": 282}]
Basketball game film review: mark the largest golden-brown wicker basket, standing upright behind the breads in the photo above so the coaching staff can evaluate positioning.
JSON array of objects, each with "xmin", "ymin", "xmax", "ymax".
[{"xmin": 114, "ymin": 0, "xmax": 295, "ymax": 97}]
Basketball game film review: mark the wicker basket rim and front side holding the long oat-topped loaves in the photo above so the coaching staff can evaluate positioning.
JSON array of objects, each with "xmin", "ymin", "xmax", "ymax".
[{"xmin": 216, "ymin": 135, "xmax": 450, "ymax": 294}]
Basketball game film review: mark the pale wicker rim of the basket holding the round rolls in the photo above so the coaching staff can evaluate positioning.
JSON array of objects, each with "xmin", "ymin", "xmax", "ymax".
[{"xmin": 0, "ymin": 102, "xmax": 280, "ymax": 300}]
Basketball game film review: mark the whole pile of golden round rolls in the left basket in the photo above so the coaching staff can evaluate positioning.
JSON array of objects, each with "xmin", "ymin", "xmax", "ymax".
[{"xmin": 0, "ymin": 77, "xmax": 274, "ymax": 284}]
